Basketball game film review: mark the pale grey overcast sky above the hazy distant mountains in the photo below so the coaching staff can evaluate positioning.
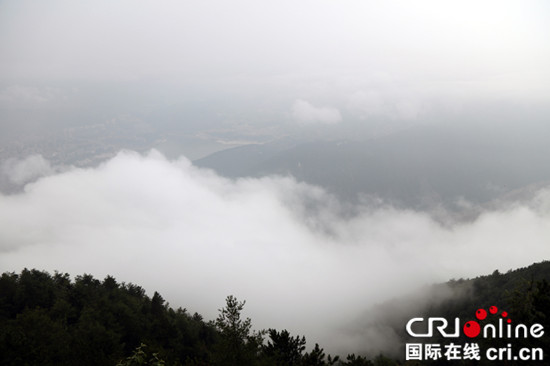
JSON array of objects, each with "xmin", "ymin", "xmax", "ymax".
[{"xmin": 0, "ymin": 0, "xmax": 550, "ymax": 120}]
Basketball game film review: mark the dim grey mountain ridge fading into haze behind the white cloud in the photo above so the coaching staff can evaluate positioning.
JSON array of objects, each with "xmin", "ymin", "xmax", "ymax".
[{"xmin": 194, "ymin": 125, "xmax": 550, "ymax": 209}]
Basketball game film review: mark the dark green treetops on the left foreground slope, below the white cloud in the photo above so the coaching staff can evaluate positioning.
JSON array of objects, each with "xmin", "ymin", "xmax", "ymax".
[{"xmin": 0, "ymin": 270, "xmax": 402, "ymax": 366}]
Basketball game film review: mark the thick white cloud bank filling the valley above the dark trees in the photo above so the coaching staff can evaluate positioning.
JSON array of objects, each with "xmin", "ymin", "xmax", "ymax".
[{"xmin": 0, "ymin": 151, "xmax": 550, "ymax": 350}]
